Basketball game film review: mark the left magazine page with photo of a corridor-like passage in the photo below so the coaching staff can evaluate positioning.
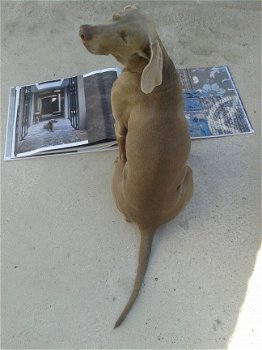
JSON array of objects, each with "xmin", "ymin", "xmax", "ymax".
[{"xmin": 5, "ymin": 68, "xmax": 117, "ymax": 159}]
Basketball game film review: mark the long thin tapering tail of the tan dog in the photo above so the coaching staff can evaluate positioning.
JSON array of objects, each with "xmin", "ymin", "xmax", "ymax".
[{"xmin": 114, "ymin": 230, "xmax": 155, "ymax": 328}]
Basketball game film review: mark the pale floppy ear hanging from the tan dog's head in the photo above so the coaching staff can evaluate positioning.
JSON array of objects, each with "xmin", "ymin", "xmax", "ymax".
[{"xmin": 141, "ymin": 38, "xmax": 163, "ymax": 94}]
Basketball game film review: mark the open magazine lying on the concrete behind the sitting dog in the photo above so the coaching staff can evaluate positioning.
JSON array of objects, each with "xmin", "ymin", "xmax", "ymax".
[{"xmin": 5, "ymin": 66, "xmax": 253, "ymax": 160}]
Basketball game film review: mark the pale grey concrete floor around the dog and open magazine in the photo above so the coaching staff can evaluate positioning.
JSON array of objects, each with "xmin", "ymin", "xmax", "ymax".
[{"xmin": 1, "ymin": 1, "xmax": 261, "ymax": 349}]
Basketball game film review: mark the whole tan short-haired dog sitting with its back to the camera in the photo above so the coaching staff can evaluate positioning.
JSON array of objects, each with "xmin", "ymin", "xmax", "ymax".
[{"xmin": 79, "ymin": 6, "xmax": 193, "ymax": 327}]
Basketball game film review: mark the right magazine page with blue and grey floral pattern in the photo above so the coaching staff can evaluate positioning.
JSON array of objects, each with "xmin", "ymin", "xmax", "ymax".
[{"xmin": 178, "ymin": 66, "xmax": 254, "ymax": 139}]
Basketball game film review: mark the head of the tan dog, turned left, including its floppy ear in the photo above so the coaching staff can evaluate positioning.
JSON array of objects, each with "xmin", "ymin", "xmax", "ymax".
[{"xmin": 79, "ymin": 5, "xmax": 163, "ymax": 94}]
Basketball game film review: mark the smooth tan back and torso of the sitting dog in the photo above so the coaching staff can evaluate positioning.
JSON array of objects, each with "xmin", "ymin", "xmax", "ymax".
[{"xmin": 112, "ymin": 56, "xmax": 192, "ymax": 228}]
